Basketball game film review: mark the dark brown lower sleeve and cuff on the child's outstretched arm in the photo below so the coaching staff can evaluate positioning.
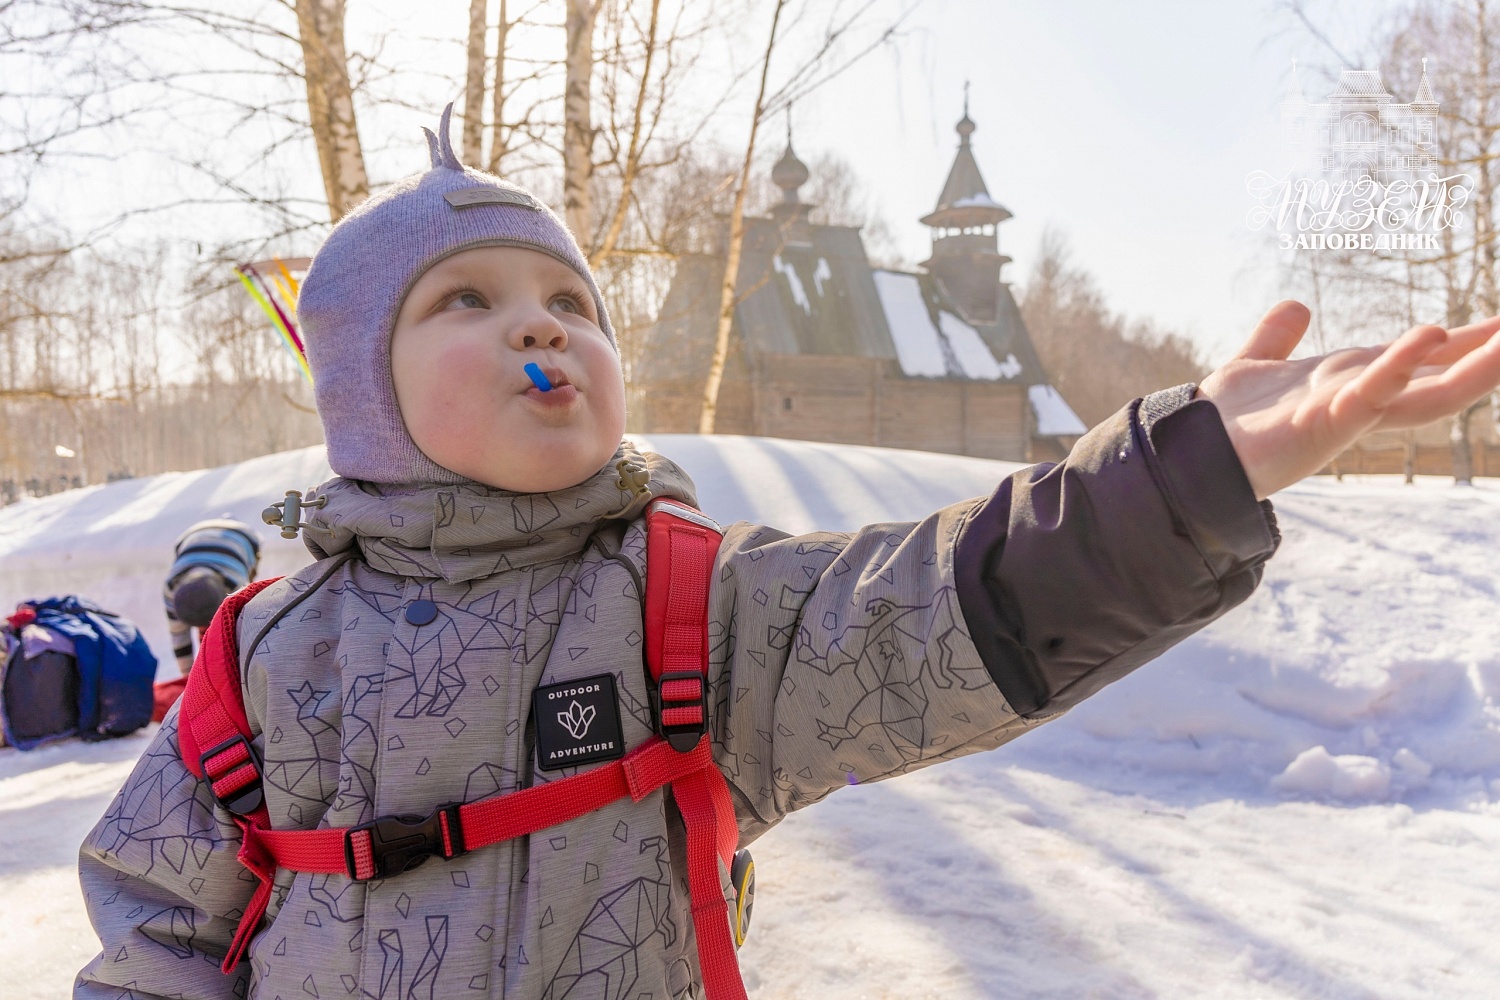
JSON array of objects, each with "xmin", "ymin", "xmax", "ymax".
[{"xmin": 954, "ymin": 385, "xmax": 1280, "ymax": 718}]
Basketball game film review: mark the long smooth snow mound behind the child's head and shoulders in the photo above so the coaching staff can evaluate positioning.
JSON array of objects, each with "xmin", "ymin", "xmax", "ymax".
[{"xmin": 0, "ymin": 435, "xmax": 1019, "ymax": 689}]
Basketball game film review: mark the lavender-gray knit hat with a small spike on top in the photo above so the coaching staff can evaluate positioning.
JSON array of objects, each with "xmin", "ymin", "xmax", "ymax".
[{"xmin": 297, "ymin": 105, "xmax": 615, "ymax": 484}]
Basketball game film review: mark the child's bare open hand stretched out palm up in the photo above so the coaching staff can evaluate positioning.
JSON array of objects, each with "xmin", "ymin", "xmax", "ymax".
[{"xmin": 1199, "ymin": 301, "xmax": 1500, "ymax": 499}]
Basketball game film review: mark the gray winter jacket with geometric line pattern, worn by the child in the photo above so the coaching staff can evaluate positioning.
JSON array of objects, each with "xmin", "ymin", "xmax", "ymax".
[{"xmin": 74, "ymin": 390, "xmax": 1277, "ymax": 1000}]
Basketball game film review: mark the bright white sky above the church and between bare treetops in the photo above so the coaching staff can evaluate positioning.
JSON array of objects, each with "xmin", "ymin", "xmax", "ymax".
[{"xmin": 17, "ymin": 0, "xmax": 1404, "ymax": 361}]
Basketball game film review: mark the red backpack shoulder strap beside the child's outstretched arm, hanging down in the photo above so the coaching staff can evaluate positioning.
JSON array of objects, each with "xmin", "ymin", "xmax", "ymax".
[{"xmin": 645, "ymin": 499, "xmax": 746, "ymax": 1000}]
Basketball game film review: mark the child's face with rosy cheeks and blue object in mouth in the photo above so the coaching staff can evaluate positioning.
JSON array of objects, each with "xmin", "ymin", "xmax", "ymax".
[{"xmin": 390, "ymin": 246, "xmax": 626, "ymax": 493}]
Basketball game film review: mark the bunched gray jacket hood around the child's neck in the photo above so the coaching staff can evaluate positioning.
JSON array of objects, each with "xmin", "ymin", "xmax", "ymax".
[{"xmin": 303, "ymin": 441, "xmax": 698, "ymax": 583}]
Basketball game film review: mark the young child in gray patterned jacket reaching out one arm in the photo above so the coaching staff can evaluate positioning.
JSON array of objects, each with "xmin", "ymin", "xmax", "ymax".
[{"xmin": 75, "ymin": 105, "xmax": 1500, "ymax": 1000}]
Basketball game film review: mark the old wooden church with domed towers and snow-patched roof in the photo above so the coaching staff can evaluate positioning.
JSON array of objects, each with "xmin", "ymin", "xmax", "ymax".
[{"xmin": 633, "ymin": 108, "xmax": 1086, "ymax": 462}]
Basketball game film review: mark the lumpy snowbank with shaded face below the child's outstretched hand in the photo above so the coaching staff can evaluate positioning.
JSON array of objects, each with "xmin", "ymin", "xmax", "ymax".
[{"xmin": 1014, "ymin": 477, "xmax": 1500, "ymax": 805}]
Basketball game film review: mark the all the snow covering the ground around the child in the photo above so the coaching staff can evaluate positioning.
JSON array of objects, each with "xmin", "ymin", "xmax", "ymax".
[{"xmin": 0, "ymin": 446, "xmax": 1500, "ymax": 1000}]
